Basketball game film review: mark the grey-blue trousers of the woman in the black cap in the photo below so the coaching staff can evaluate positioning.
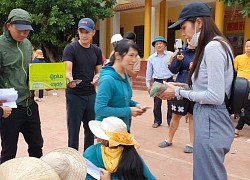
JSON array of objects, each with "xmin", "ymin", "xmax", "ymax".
[{"xmin": 193, "ymin": 103, "xmax": 234, "ymax": 180}]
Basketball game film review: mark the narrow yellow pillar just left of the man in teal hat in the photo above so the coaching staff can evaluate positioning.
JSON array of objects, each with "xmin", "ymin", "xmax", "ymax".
[{"xmin": 143, "ymin": 0, "xmax": 152, "ymax": 59}]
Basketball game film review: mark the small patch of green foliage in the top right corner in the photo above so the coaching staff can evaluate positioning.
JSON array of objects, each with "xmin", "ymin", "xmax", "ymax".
[{"xmin": 221, "ymin": 0, "xmax": 250, "ymax": 18}]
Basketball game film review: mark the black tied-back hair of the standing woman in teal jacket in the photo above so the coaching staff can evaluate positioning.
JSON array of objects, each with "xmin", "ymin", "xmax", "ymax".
[{"xmin": 108, "ymin": 39, "xmax": 139, "ymax": 66}]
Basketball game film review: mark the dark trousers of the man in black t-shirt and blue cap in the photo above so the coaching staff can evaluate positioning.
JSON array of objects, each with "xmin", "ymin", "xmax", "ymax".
[{"xmin": 66, "ymin": 93, "xmax": 96, "ymax": 151}]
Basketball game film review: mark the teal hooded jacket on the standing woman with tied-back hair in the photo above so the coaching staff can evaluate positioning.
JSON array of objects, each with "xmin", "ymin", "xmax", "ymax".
[{"xmin": 95, "ymin": 65, "xmax": 138, "ymax": 130}]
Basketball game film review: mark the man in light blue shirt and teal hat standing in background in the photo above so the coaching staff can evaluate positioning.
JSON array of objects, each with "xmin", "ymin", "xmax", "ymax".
[{"xmin": 146, "ymin": 36, "xmax": 173, "ymax": 128}]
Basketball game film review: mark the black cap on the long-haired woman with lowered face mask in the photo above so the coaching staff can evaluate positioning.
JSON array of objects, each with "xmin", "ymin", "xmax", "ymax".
[{"xmin": 168, "ymin": 2, "xmax": 211, "ymax": 30}]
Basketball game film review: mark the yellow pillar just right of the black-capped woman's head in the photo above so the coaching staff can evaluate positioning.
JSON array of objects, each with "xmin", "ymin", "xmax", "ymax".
[{"xmin": 215, "ymin": 0, "xmax": 225, "ymax": 33}]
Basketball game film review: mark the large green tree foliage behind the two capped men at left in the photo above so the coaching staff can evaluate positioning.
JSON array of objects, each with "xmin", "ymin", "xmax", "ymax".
[{"xmin": 0, "ymin": 0, "xmax": 116, "ymax": 61}]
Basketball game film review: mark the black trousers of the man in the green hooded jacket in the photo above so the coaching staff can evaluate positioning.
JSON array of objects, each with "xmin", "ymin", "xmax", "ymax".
[{"xmin": 0, "ymin": 102, "xmax": 43, "ymax": 163}]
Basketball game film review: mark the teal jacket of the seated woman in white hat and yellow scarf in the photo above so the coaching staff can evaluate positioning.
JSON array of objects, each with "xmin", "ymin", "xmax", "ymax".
[{"xmin": 83, "ymin": 143, "xmax": 156, "ymax": 180}]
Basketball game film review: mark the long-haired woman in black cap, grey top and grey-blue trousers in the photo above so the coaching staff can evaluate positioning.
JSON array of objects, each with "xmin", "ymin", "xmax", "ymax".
[{"xmin": 160, "ymin": 2, "xmax": 234, "ymax": 180}]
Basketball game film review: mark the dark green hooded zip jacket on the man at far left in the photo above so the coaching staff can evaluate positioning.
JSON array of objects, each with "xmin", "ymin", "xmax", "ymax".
[{"xmin": 0, "ymin": 9, "xmax": 34, "ymax": 107}]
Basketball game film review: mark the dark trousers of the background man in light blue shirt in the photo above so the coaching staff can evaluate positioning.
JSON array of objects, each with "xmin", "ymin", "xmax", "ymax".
[{"xmin": 153, "ymin": 77, "xmax": 174, "ymax": 125}]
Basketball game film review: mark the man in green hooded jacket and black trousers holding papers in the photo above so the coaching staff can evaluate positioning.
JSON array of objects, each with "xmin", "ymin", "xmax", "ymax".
[{"xmin": 0, "ymin": 9, "xmax": 43, "ymax": 163}]
